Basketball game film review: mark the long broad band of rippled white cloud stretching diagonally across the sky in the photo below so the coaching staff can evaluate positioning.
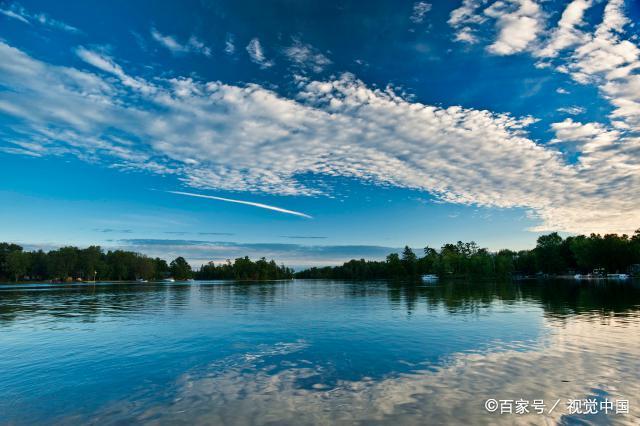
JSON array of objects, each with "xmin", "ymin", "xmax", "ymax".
[{"xmin": 0, "ymin": 42, "xmax": 640, "ymax": 232}]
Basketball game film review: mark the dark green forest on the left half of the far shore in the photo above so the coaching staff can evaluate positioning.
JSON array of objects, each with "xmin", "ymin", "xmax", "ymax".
[{"xmin": 0, "ymin": 243, "xmax": 293, "ymax": 281}]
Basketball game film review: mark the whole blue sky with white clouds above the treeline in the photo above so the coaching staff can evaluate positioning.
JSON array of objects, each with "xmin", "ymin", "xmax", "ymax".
[{"xmin": 0, "ymin": 0, "xmax": 640, "ymax": 267}]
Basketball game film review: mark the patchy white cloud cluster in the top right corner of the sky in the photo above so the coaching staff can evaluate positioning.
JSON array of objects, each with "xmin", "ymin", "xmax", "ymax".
[{"xmin": 456, "ymin": 0, "xmax": 640, "ymax": 131}]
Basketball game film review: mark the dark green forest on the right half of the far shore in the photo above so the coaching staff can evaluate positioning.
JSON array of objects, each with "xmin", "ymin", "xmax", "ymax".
[{"xmin": 295, "ymin": 230, "xmax": 640, "ymax": 279}]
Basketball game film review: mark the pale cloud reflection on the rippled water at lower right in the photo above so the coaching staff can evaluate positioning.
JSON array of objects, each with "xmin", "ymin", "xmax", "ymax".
[{"xmin": 94, "ymin": 312, "xmax": 640, "ymax": 425}]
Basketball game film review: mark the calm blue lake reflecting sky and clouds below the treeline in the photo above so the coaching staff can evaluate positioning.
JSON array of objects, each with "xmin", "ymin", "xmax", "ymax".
[{"xmin": 0, "ymin": 280, "xmax": 640, "ymax": 425}]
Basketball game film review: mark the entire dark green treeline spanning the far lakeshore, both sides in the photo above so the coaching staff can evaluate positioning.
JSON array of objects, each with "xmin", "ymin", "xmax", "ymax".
[{"xmin": 0, "ymin": 230, "xmax": 640, "ymax": 281}]
